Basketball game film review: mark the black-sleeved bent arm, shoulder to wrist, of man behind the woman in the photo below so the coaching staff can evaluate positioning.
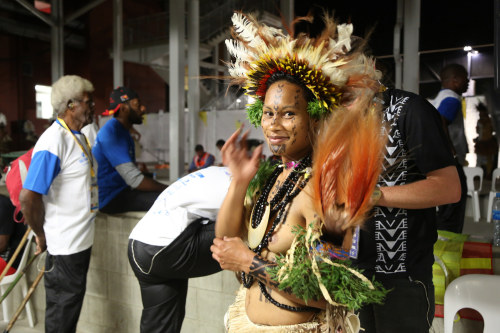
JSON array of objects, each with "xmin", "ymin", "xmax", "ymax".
[{"xmin": 377, "ymin": 93, "xmax": 461, "ymax": 209}]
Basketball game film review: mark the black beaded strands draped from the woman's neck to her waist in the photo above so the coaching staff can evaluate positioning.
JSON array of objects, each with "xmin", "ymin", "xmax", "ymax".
[{"xmin": 241, "ymin": 155, "xmax": 316, "ymax": 312}]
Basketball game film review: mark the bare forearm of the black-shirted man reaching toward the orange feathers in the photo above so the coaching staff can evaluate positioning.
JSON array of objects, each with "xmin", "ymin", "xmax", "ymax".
[{"xmin": 377, "ymin": 165, "xmax": 461, "ymax": 209}]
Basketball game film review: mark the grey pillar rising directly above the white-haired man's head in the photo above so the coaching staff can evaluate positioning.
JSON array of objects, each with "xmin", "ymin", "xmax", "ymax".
[{"xmin": 50, "ymin": 0, "xmax": 64, "ymax": 83}]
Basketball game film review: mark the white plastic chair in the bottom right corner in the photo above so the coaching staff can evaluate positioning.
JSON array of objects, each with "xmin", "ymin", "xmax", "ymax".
[{"xmin": 444, "ymin": 274, "xmax": 500, "ymax": 333}]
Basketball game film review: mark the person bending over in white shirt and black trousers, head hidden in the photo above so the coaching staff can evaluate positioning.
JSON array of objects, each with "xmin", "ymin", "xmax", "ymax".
[{"xmin": 128, "ymin": 167, "xmax": 230, "ymax": 333}]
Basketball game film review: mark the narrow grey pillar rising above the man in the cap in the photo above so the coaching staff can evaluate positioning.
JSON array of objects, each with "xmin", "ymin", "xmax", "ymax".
[{"xmin": 113, "ymin": 0, "xmax": 123, "ymax": 88}]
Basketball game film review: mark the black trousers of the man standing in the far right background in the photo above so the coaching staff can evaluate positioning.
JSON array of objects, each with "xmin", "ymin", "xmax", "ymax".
[{"xmin": 436, "ymin": 160, "xmax": 467, "ymax": 234}]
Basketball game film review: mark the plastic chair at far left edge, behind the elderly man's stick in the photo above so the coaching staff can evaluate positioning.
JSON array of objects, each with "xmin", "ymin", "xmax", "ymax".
[{"xmin": 0, "ymin": 231, "xmax": 36, "ymax": 327}]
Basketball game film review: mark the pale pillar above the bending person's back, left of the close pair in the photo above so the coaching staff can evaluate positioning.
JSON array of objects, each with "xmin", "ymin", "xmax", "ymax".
[{"xmin": 169, "ymin": 0, "xmax": 185, "ymax": 182}]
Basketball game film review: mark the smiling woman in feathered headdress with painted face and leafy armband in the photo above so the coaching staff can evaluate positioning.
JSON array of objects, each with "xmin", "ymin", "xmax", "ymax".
[{"xmin": 212, "ymin": 13, "xmax": 385, "ymax": 333}]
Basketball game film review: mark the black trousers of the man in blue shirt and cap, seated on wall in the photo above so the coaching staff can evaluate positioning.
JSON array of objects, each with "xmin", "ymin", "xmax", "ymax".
[{"xmin": 99, "ymin": 187, "xmax": 161, "ymax": 214}]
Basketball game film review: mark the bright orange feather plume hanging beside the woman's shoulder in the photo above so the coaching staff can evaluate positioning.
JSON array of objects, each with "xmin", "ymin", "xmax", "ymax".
[{"xmin": 311, "ymin": 93, "xmax": 386, "ymax": 249}]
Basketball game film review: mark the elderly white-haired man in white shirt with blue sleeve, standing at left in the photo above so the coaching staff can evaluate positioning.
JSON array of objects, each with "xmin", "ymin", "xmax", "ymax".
[{"xmin": 20, "ymin": 75, "xmax": 98, "ymax": 332}]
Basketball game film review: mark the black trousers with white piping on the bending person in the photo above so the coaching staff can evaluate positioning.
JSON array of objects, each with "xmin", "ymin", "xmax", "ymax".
[{"xmin": 128, "ymin": 220, "xmax": 221, "ymax": 333}]
